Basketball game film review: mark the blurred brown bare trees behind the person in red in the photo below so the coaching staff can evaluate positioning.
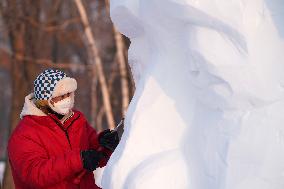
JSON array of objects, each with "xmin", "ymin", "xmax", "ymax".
[{"xmin": 0, "ymin": 0, "xmax": 134, "ymax": 189}]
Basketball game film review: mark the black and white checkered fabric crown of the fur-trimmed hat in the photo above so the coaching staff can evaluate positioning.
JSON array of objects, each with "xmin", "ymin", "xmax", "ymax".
[{"xmin": 34, "ymin": 69, "xmax": 67, "ymax": 100}]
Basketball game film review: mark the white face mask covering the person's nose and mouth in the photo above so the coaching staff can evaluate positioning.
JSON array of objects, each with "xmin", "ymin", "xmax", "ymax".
[{"xmin": 48, "ymin": 95, "xmax": 74, "ymax": 115}]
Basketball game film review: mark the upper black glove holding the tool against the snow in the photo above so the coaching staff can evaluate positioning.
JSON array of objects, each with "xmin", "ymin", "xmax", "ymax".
[{"xmin": 99, "ymin": 129, "xmax": 119, "ymax": 151}]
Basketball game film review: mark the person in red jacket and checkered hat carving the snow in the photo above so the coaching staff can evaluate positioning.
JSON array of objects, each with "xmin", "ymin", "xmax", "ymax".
[{"xmin": 8, "ymin": 69, "xmax": 119, "ymax": 189}]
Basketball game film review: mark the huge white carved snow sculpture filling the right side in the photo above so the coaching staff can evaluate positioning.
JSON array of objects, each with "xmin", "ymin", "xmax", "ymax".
[{"xmin": 102, "ymin": 0, "xmax": 284, "ymax": 189}]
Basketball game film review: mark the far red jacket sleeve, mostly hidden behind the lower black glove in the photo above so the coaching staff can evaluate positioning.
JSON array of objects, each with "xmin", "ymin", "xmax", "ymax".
[{"xmin": 87, "ymin": 123, "xmax": 112, "ymax": 167}]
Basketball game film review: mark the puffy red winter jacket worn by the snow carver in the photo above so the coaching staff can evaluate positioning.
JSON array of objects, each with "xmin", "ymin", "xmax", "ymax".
[{"xmin": 8, "ymin": 110, "xmax": 111, "ymax": 189}]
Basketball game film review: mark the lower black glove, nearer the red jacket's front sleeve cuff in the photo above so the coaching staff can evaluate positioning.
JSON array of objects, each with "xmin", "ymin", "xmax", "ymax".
[{"xmin": 81, "ymin": 150, "xmax": 105, "ymax": 172}]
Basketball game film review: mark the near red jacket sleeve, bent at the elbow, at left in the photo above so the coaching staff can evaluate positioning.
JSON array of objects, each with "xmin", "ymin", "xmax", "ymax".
[{"xmin": 8, "ymin": 135, "xmax": 83, "ymax": 188}]
